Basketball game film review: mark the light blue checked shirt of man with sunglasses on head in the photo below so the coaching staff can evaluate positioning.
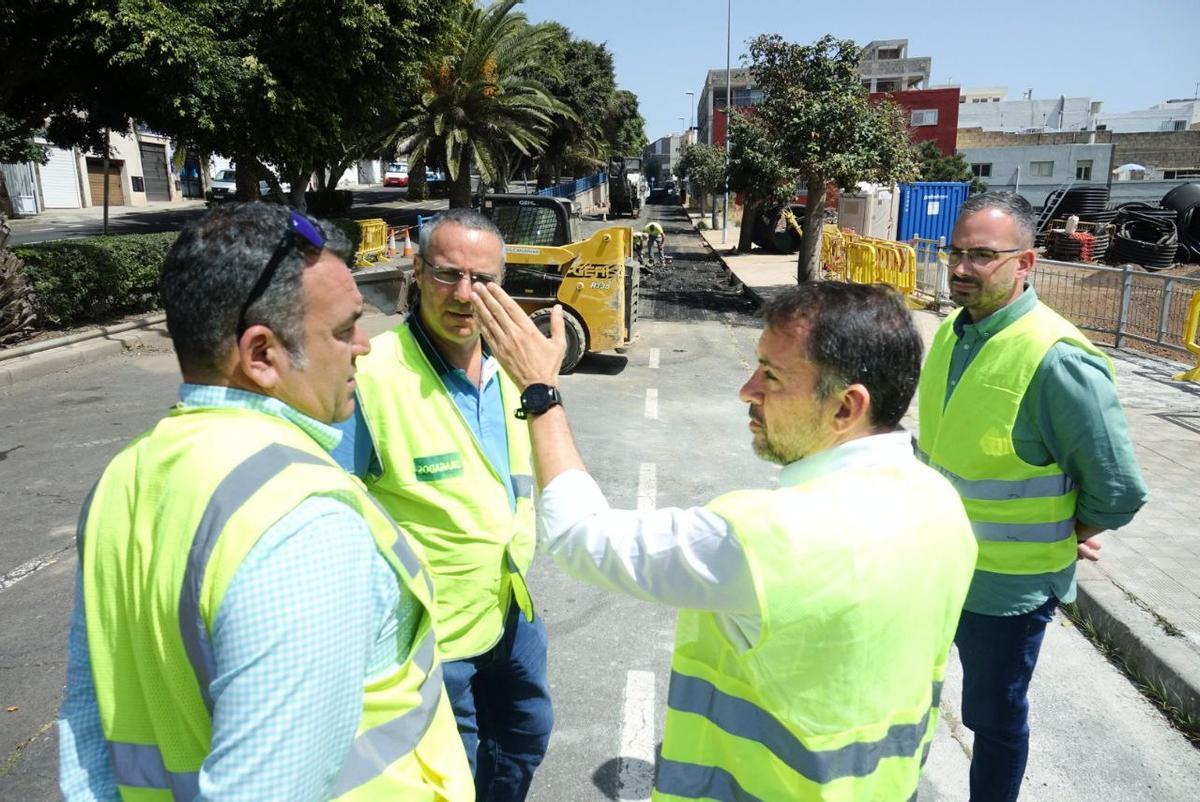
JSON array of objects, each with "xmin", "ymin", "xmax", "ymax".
[{"xmin": 59, "ymin": 384, "xmax": 420, "ymax": 802}]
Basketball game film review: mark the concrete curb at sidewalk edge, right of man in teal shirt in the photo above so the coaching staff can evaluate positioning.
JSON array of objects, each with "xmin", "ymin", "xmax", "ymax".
[{"xmin": 1075, "ymin": 567, "xmax": 1200, "ymax": 718}]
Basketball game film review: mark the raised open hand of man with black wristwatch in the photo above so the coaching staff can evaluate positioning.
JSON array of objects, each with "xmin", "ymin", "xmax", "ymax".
[{"xmin": 470, "ymin": 282, "xmax": 566, "ymax": 389}]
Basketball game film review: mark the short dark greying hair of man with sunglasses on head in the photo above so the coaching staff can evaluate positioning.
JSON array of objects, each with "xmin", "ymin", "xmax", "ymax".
[{"xmin": 160, "ymin": 203, "xmax": 353, "ymax": 372}]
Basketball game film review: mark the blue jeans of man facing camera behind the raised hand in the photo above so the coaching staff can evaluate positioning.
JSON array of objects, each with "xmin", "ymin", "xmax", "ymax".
[{"xmin": 442, "ymin": 602, "xmax": 554, "ymax": 802}]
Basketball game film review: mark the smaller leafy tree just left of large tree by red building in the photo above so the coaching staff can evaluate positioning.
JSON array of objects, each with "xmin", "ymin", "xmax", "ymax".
[{"xmin": 730, "ymin": 112, "xmax": 798, "ymax": 252}]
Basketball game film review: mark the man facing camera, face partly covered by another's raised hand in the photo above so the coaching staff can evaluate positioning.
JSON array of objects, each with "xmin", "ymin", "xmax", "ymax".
[{"xmin": 336, "ymin": 209, "xmax": 553, "ymax": 802}]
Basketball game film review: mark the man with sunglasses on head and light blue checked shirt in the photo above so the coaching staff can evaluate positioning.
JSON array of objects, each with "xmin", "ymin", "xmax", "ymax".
[{"xmin": 59, "ymin": 203, "xmax": 474, "ymax": 802}]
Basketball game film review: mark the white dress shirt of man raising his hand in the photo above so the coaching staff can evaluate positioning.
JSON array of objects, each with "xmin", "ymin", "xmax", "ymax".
[{"xmin": 538, "ymin": 431, "xmax": 916, "ymax": 650}]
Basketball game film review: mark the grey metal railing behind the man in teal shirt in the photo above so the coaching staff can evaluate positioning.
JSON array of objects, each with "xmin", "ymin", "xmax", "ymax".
[{"xmin": 910, "ymin": 238, "xmax": 1200, "ymax": 354}]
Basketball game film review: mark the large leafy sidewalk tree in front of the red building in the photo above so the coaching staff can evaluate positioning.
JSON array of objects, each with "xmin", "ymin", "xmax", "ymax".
[{"xmin": 750, "ymin": 34, "xmax": 917, "ymax": 281}]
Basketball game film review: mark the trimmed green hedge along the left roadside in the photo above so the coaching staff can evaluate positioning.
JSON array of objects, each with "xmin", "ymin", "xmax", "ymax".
[{"xmin": 13, "ymin": 232, "xmax": 176, "ymax": 325}]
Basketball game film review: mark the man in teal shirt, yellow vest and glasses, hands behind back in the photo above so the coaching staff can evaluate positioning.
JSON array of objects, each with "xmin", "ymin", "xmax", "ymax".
[{"xmin": 918, "ymin": 192, "xmax": 1146, "ymax": 802}]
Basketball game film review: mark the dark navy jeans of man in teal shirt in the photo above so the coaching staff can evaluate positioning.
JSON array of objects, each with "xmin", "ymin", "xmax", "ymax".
[{"xmin": 954, "ymin": 597, "xmax": 1058, "ymax": 802}]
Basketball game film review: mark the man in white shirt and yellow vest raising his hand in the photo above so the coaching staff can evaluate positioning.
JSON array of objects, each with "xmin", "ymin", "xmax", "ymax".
[{"xmin": 475, "ymin": 282, "xmax": 976, "ymax": 802}]
